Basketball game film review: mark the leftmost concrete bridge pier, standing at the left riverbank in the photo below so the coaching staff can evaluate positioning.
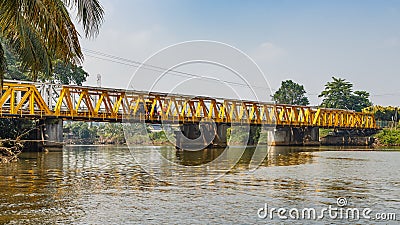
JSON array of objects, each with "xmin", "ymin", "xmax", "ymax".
[{"xmin": 37, "ymin": 119, "xmax": 63, "ymax": 151}]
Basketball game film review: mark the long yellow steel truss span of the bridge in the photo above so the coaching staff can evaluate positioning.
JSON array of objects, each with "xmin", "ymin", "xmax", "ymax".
[{"xmin": 0, "ymin": 82, "xmax": 378, "ymax": 129}]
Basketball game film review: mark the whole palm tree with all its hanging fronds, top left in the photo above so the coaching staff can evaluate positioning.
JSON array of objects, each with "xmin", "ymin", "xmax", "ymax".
[{"xmin": 0, "ymin": 0, "xmax": 104, "ymax": 90}]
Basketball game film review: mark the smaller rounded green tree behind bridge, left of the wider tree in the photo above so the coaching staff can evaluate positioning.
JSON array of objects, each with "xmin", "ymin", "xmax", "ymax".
[{"xmin": 272, "ymin": 80, "xmax": 310, "ymax": 105}]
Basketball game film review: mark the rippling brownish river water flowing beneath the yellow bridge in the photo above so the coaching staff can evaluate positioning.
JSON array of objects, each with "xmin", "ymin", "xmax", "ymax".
[{"xmin": 0, "ymin": 146, "xmax": 400, "ymax": 224}]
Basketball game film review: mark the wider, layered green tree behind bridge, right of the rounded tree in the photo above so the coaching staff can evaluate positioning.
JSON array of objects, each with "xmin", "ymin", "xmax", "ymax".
[{"xmin": 318, "ymin": 77, "xmax": 372, "ymax": 112}]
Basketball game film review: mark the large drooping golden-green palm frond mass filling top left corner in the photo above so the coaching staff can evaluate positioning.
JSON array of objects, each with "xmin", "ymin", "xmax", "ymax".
[{"xmin": 0, "ymin": 0, "xmax": 83, "ymax": 66}]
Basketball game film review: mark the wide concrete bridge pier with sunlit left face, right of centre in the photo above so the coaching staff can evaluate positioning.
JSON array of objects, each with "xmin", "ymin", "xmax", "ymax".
[{"xmin": 268, "ymin": 127, "xmax": 319, "ymax": 146}]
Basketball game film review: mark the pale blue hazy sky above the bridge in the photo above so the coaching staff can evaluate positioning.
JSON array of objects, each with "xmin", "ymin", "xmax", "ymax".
[{"xmin": 81, "ymin": 0, "xmax": 400, "ymax": 106}]
